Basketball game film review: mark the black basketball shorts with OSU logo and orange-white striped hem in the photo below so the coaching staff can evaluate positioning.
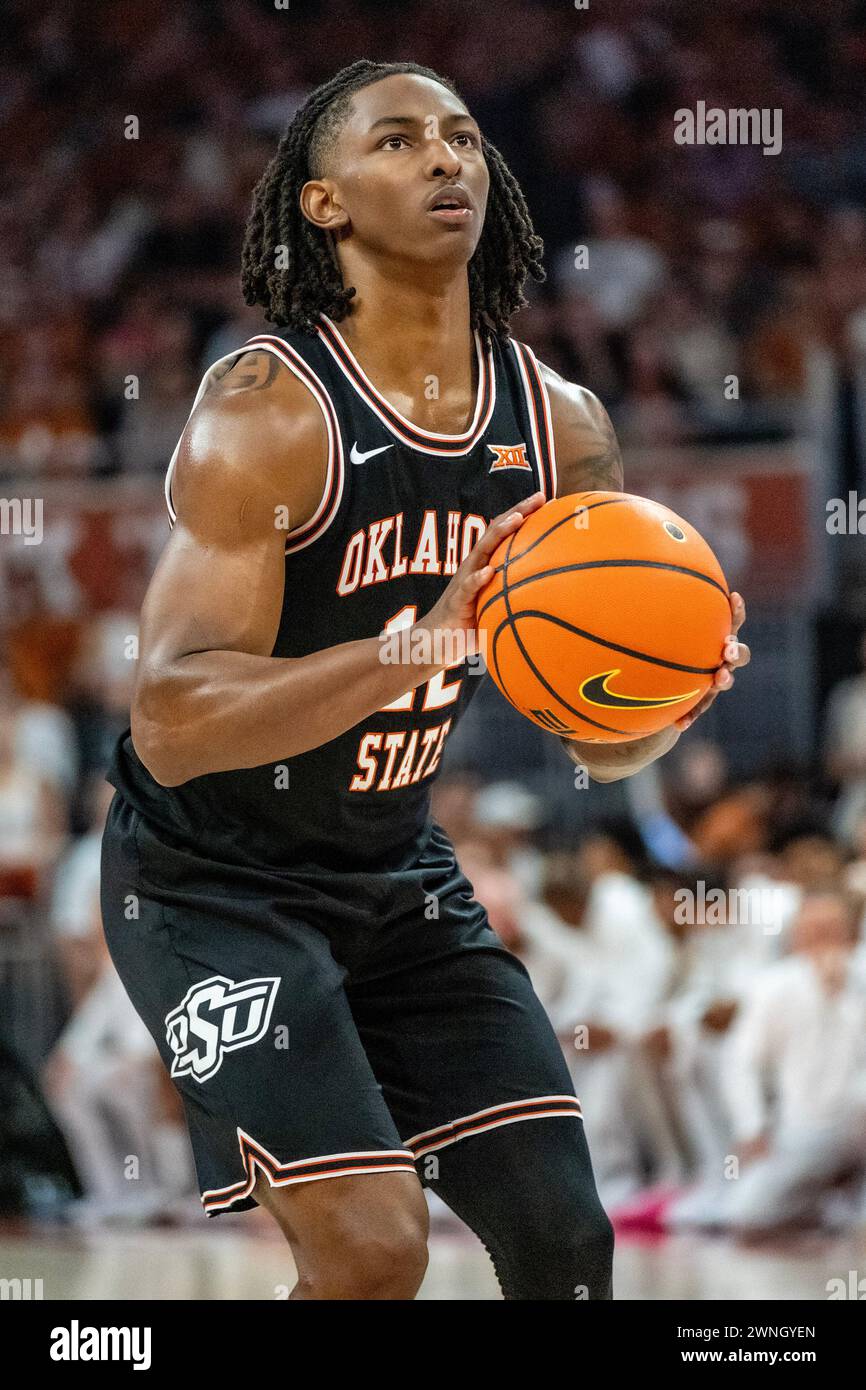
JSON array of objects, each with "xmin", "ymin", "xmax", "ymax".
[{"xmin": 101, "ymin": 792, "xmax": 581, "ymax": 1215}]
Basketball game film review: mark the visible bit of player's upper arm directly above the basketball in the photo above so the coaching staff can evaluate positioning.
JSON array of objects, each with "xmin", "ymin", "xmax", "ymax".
[{"xmin": 542, "ymin": 366, "xmax": 623, "ymax": 498}]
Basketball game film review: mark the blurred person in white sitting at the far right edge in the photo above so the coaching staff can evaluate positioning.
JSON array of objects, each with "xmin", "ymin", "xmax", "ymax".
[{"xmin": 671, "ymin": 890, "xmax": 866, "ymax": 1234}]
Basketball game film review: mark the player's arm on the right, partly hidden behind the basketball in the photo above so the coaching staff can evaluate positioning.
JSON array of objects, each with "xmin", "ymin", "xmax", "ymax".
[{"xmin": 541, "ymin": 366, "xmax": 751, "ymax": 781}]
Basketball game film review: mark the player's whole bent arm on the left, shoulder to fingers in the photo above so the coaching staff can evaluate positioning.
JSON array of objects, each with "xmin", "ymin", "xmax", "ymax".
[{"xmin": 131, "ymin": 352, "xmax": 539, "ymax": 787}]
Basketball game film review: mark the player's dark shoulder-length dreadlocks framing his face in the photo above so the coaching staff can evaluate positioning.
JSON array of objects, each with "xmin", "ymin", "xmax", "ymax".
[{"xmin": 240, "ymin": 58, "xmax": 545, "ymax": 334}]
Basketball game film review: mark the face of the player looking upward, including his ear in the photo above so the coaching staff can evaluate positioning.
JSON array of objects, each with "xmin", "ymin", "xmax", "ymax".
[{"xmin": 307, "ymin": 74, "xmax": 489, "ymax": 264}]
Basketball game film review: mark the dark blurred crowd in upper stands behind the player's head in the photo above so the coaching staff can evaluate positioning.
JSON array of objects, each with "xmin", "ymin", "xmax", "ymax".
[{"xmin": 0, "ymin": 0, "xmax": 866, "ymax": 485}]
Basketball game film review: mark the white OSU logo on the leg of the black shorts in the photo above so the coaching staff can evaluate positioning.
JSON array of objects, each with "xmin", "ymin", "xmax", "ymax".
[{"xmin": 165, "ymin": 974, "xmax": 279, "ymax": 1081}]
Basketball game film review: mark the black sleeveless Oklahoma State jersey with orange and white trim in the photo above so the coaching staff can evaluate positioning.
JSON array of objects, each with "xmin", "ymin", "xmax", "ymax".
[{"xmin": 108, "ymin": 317, "xmax": 556, "ymax": 869}]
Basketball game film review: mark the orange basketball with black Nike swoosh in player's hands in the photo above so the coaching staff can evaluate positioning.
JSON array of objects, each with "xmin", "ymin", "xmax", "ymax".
[{"xmin": 478, "ymin": 492, "xmax": 731, "ymax": 744}]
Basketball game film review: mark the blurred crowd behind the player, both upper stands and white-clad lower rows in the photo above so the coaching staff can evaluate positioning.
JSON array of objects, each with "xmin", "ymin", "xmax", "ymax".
[{"xmin": 0, "ymin": 0, "xmax": 866, "ymax": 1234}]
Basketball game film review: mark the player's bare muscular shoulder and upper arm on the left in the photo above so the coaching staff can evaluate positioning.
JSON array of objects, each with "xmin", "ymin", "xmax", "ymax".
[{"xmin": 140, "ymin": 368, "xmax": 327, "ymax": 670}]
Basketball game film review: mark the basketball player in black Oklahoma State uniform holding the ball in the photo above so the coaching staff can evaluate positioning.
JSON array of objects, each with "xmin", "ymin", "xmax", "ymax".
[{"xmin": 103, "ymin": 61, "xmax": 748, "ymax": 1300}]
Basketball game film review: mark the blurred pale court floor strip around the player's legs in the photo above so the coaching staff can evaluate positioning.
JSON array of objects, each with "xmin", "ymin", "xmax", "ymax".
[{"xmin": 0, "ymin": 1212, "xmax": 866, "ymax": 1301}]
